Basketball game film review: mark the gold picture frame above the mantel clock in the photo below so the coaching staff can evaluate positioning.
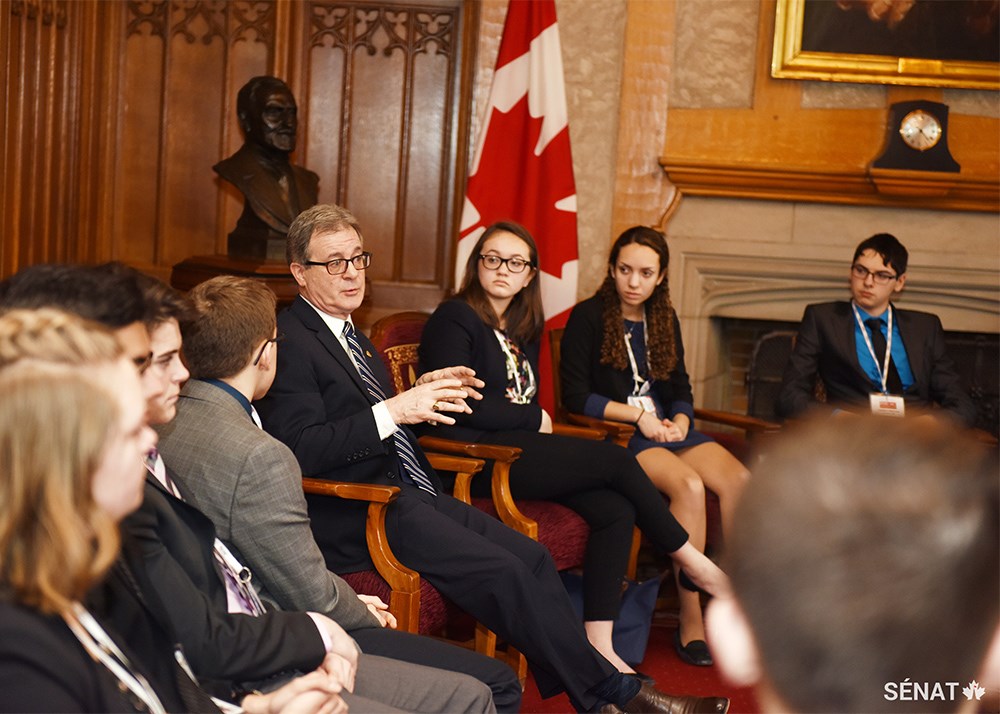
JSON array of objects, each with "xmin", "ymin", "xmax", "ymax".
[{"xmin": 771, "ymin": 0, "xmax": 1000, "ymax": 90}]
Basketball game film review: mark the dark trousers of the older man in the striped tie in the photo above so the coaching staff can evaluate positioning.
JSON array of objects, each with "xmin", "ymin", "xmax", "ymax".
[{"xmin": 386, "ymin": 485, "xmax": 617, "ymax": 711}]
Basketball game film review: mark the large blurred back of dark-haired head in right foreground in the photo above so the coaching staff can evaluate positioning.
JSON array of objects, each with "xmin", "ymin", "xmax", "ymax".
[{"xmin": 724, "ymin": 416, "xmax": 1000, "ymax": 712}]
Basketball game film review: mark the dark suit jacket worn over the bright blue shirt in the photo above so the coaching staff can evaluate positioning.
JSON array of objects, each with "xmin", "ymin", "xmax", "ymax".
[{"xmin": 777, "ymin": 301, "xmax": 976, "ymax": 424}]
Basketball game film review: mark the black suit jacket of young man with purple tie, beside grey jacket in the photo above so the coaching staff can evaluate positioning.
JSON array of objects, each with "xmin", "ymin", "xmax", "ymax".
[{"xmin": 122, "ymin": 476, "xmax": 326, "ymax": 682}]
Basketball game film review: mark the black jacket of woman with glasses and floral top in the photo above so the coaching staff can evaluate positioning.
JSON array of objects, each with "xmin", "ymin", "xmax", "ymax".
[{"xmin": 419, "ymin": 300, "xmax": 542, "ymax": 441}]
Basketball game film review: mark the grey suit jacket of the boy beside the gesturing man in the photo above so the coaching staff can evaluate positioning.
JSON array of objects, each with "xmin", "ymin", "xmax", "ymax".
[{"xmin": 159, "ymin": 379, "xmax": 380, "ymax": 630}]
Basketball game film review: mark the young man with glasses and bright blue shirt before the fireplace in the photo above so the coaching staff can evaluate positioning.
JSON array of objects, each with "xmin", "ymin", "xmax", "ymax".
[{"xmin": 777, "ymin": 233, "xmax": 975, "ymax": 425}]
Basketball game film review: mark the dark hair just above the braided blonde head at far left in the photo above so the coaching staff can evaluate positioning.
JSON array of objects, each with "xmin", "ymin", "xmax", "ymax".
[{"xmin": 0, "ymin": 263, "xmax": 146, "ymax": 330}]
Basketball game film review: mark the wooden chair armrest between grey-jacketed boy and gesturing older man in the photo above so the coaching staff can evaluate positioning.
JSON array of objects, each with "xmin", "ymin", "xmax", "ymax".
[{"xmin": 302, "ymin": 478, "xmax": 420, "ymax": 634}]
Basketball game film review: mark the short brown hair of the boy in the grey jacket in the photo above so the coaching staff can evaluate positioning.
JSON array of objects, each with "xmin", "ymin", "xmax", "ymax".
[{"xmin": 181, "ymin": 275, "xmax": 277, "ymax": 379}]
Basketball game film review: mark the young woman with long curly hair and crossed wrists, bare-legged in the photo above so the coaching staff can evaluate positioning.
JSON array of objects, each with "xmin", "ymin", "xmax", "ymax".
[{"xmin": 560, "ymin": 226, "xmax": 749, "ymax": 661}]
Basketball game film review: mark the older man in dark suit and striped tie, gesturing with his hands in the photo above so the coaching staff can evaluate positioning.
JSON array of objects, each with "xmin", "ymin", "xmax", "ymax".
[{"xmin": 257, "ymin": 205, "xmax": 729, "ymax": 712}]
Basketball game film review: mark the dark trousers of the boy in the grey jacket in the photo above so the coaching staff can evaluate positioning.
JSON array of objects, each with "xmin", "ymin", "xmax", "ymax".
[{"xmin": 350, "ymin": 627, "xmax": 521, "ymax": 712}]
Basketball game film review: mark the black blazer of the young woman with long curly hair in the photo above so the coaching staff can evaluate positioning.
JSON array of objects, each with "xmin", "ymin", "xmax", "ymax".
[{"xmin": 559, "ymin": 295, "xmax": 694, "ymax": 416}]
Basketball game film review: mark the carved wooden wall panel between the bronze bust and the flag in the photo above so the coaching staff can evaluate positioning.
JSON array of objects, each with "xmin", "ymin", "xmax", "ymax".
[{"xmin": 299, "ymin": 0, "xmax": 471, "ymax": 307}]
